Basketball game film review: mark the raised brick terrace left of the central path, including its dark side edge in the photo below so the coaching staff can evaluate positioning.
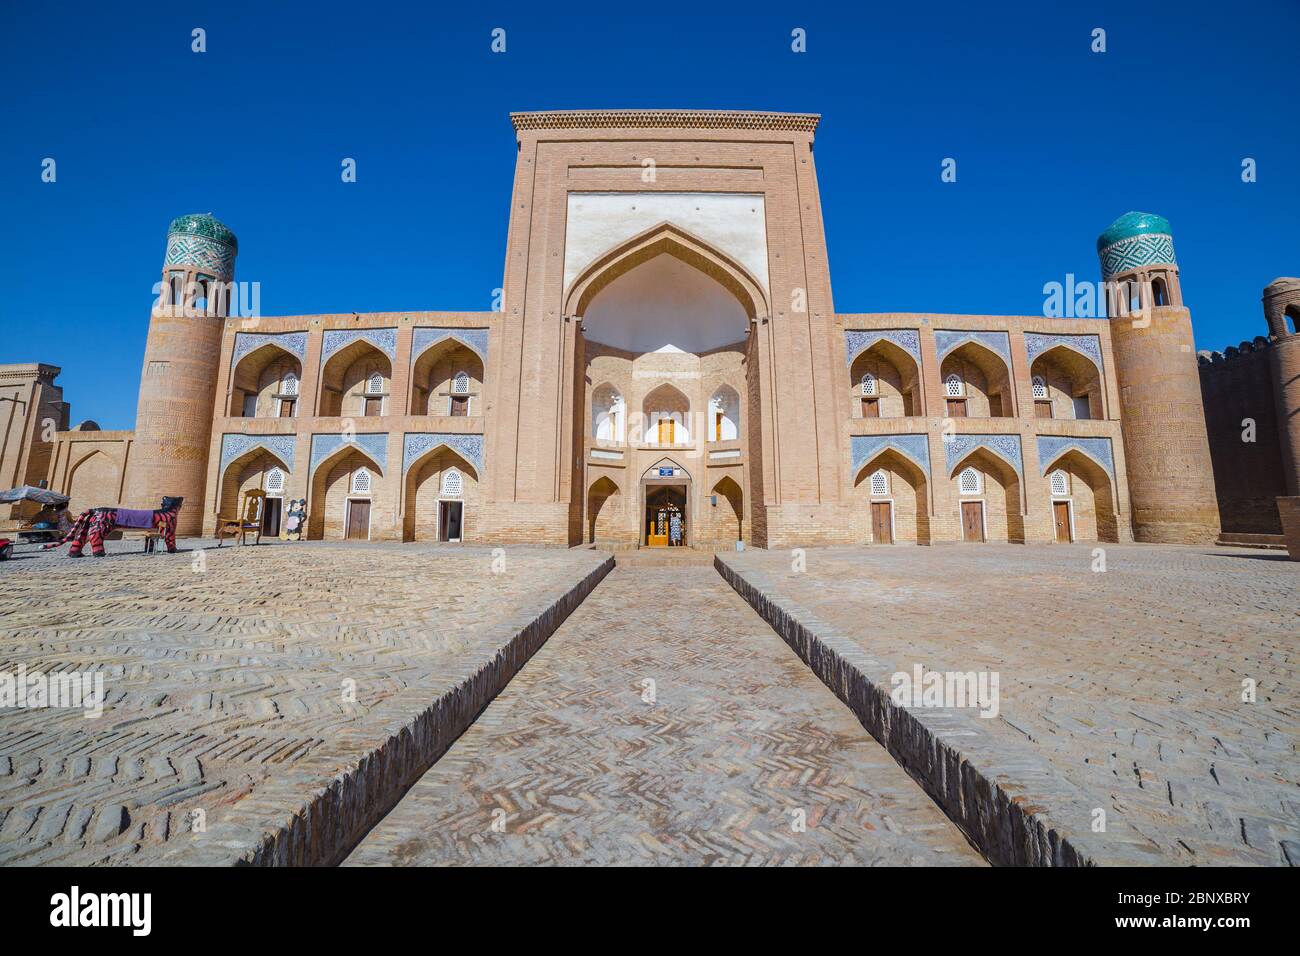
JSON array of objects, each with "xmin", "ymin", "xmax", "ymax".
[{"xmin": 0, "ymin": 542, "xmax": 610, "ymax": 864}]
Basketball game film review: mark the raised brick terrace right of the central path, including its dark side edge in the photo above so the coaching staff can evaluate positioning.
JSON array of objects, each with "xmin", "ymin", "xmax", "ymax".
[{"xmin": 719, "ymin": 545, "xmax": 1300, "ymax": 865}]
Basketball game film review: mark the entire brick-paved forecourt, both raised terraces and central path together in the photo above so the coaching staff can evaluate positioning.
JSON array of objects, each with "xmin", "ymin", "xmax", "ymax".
[{"xmin": 0, "ymin": 540, "xmax": 1300, "ymax": 865}]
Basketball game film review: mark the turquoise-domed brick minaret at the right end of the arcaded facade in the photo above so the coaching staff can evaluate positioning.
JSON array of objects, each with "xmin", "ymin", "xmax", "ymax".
[{"xmin": 1097, "ymin": 212, "xmax": 1219, "ymax": 544}]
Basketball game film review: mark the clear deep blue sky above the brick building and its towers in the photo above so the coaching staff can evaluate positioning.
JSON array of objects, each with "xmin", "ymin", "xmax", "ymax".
[{"xmin": 0, "ymin": 0, "xmax": 1300, "ymax": 428}]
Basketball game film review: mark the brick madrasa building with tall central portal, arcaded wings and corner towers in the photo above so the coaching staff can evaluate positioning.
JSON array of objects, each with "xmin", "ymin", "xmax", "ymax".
[{"xmin": 4, "ymin": 111, "xmax": 1300, "ymax": 550}]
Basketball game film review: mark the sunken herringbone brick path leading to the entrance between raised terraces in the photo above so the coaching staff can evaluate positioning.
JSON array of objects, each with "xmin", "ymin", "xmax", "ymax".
[{"xmin": 346, "ymin": 564, "xmax": 983, "ymax": 865}]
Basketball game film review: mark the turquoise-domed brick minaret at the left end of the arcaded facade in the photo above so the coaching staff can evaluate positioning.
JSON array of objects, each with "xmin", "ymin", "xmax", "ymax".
[{"xmin": 125, "ymin": 213, "xmax": 239, "ymax": 536}]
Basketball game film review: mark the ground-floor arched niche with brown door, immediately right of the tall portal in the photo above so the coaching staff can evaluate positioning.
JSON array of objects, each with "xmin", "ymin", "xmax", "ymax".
[{"xmin": 853, "ymin": 449, "xmax": 931, "ymax": 545}]
